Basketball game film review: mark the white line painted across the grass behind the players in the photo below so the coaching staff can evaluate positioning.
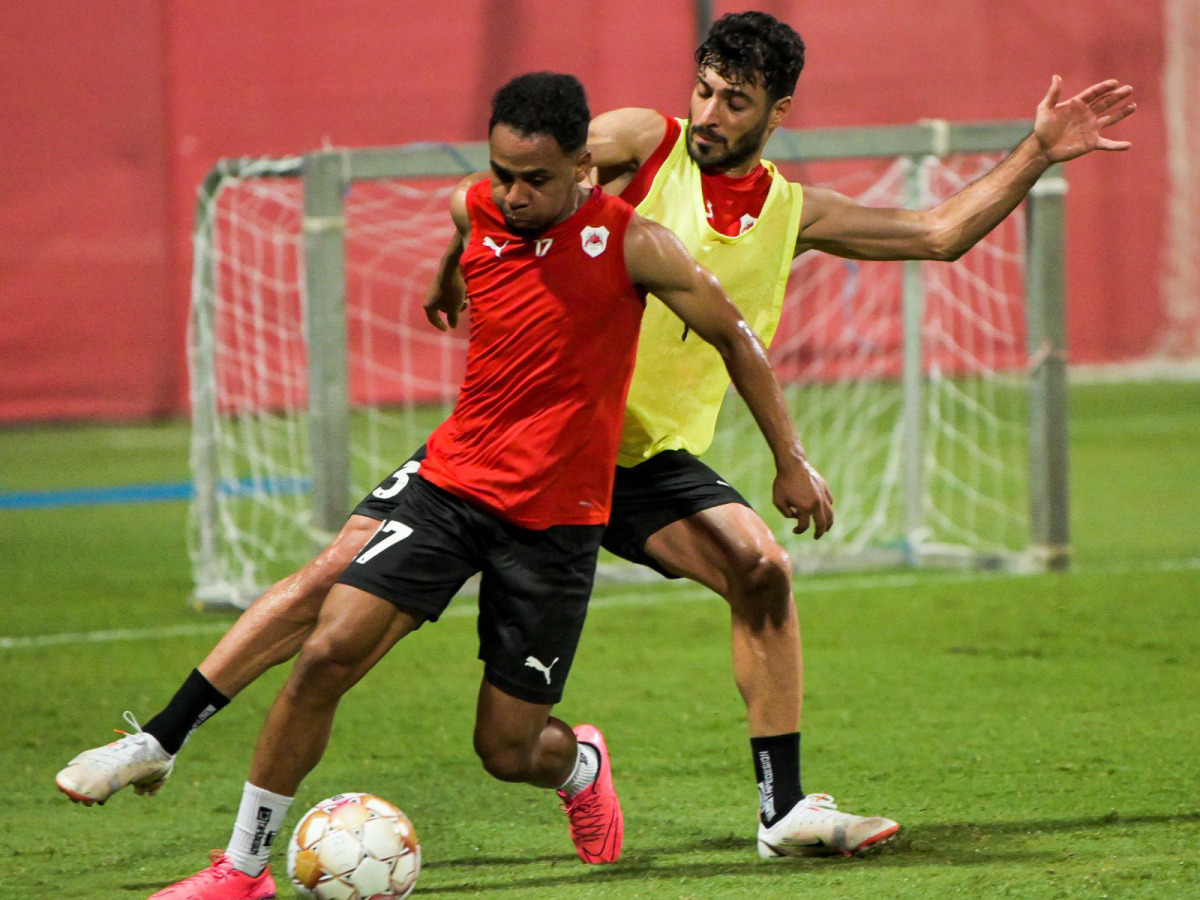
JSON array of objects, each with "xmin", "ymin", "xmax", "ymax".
[{"xmin": 0, "ymin": 557, "xmax": 1200, "ymax": 650}]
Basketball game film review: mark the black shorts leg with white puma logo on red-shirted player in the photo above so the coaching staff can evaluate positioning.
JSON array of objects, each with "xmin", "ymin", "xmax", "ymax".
[{"xmin": 478, "ymin": 523, "xmax": 604, "ymax": 704}]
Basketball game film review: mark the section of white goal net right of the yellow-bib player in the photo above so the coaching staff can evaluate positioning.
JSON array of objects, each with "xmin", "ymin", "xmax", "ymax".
[{"xmin": 708, "ymin": 156, "xmax": 1028, "ymax": 569}]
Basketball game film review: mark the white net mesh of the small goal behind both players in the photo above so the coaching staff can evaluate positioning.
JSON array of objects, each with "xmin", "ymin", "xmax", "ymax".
[{"xmin": 192, "ymin": 156, "xmax": 1028, "ymax": 604}]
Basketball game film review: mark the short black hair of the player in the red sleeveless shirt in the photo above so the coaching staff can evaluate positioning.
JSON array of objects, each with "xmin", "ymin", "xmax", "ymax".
[{"xmin": 487, "ymin": 72, "xmax": 592, "ymax": 152}]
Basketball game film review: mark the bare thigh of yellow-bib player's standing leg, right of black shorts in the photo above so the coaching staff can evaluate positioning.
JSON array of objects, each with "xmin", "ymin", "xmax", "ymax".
[{"xmin": 646, "ymin": 503, "xmax": 788, "ymax": 595}]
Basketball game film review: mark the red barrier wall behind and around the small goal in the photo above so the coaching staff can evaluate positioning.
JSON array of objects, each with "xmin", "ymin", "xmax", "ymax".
[{"xmin": 0, "ymin": 0, "xmax": 1166, "ymax": 421}]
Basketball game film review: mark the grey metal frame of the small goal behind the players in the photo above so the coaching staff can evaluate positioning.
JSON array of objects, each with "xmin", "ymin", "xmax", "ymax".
[{"xmin": 190, "ymin": 120, "xmax": 1070, "ymax": 606}]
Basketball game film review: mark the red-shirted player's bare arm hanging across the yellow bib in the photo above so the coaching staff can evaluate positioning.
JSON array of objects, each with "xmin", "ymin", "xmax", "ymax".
[{"xmin": 625, "ymin": 216, "xmax": 833, "ymax": 538}]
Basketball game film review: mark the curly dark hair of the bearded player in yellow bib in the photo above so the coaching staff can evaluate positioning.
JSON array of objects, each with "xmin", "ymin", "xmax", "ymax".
[{"xmin": 696, "ymin": 11, "xmax": 804, "ymax": 103}]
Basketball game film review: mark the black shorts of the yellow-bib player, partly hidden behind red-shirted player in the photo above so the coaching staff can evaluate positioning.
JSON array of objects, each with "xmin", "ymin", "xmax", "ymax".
[{"xmin": 354, "ymin": 446, "xmax": 750, "ymax": 578}]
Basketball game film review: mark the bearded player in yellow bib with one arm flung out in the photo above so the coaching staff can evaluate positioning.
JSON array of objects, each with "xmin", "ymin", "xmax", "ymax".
[{"xmin": 571, "ymin": 12, "xmax": 1135, "ymax": 857}]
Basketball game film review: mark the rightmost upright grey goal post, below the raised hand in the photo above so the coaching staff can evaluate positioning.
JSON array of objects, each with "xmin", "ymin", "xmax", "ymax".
[{"xmin": 1026, "ymin": 168, "xmax": 1070, "ymax": 569}]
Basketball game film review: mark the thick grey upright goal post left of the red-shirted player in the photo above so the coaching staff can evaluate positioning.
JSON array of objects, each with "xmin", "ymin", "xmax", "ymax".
[{"xmin": 304, "ymin": 152, "xmax": 350, "ymax": 534}]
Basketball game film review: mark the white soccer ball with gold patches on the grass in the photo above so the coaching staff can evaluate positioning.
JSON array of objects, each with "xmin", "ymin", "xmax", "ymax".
[{"xmin": 288, "ymin": 793, "xmax": 421, "ymax": 900}]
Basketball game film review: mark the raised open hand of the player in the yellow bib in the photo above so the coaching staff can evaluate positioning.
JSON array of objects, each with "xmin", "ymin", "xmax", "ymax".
[{"xmin": 1033, "ymin": 76, "xmax": 1138, "ymax": 163}]
